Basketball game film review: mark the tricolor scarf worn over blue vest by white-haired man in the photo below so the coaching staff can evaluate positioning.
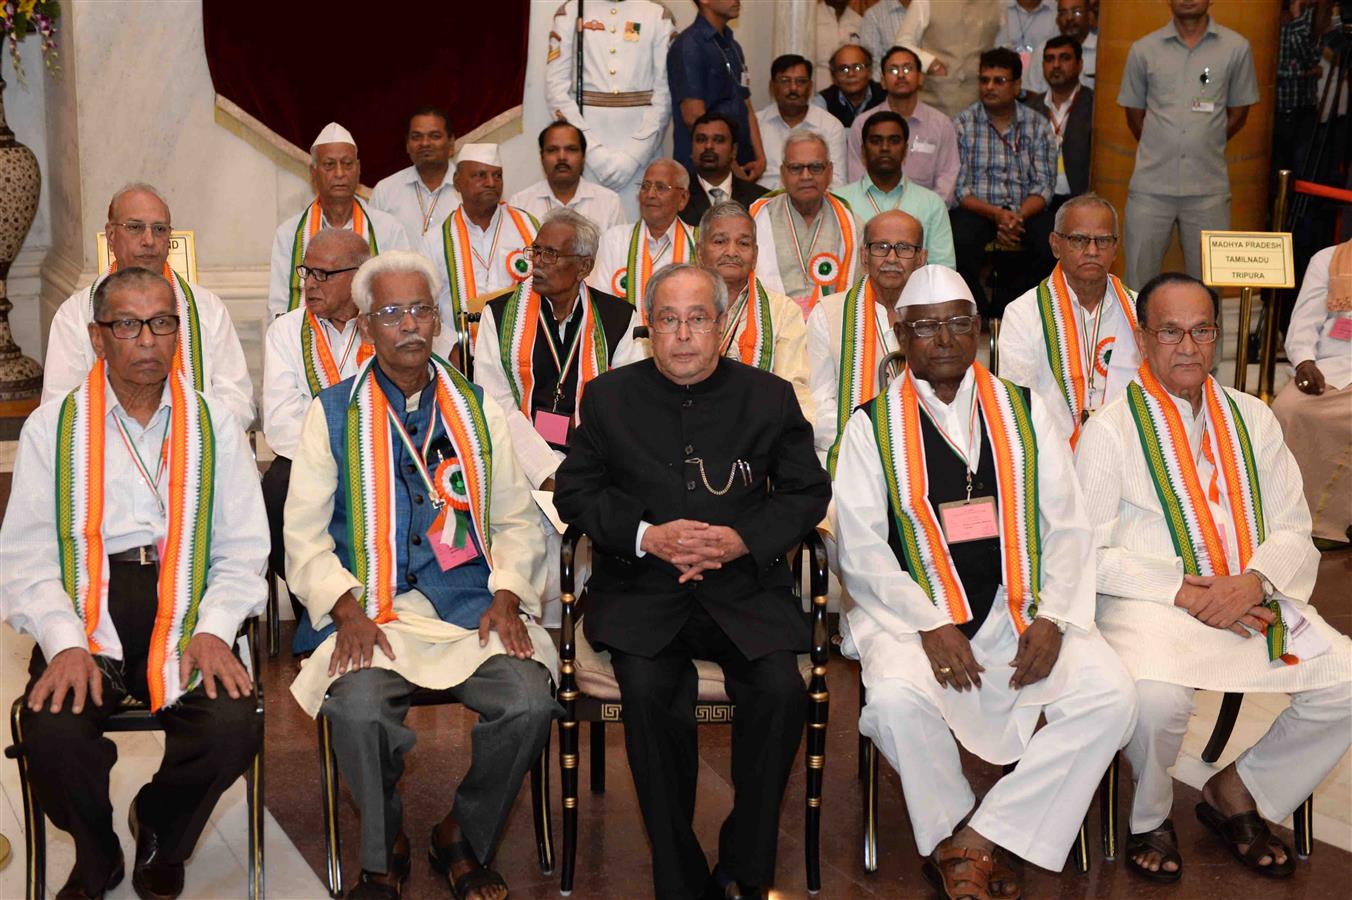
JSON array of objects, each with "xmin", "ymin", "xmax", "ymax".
[{"xmin": 339, "ymin": 355, "xmax": 493, "ymax": 624}]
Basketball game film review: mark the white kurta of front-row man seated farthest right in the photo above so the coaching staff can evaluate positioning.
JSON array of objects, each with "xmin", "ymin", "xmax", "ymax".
[{"xmin": 1075, "ymin": 388, "xmax": 1352, "ymax": 693}]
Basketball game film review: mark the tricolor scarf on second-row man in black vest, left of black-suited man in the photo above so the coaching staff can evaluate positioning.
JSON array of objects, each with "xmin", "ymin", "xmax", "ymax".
[{"xmin": 498, "ymin": 282, "xmax": 610, "ymax": 424}]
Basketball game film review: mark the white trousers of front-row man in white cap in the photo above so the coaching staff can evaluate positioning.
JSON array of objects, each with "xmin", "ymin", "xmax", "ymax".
[{"xmin": 859, "ymin": 635, "xmax": 1134, "ymax": 872}]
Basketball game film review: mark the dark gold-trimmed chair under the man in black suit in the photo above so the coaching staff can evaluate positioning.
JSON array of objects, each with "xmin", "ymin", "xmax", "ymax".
[{"xmin": 558, "ymin": 528, "xmax": 830, "ymax": 895}]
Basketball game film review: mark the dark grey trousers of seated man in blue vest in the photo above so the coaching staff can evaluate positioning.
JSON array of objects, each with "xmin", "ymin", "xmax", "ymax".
[{"xmin": 320, "ymin": 655, "xmax": 562, "ymax": 872}]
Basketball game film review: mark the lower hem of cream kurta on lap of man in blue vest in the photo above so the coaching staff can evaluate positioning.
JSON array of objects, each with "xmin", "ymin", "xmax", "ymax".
[{"xmin": 291, "ymin": 591, "xmax": 558, "ymax": 716}]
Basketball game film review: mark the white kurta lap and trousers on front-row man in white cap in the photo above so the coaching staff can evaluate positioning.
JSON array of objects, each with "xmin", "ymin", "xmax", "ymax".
[{"xmin": 854, "ymin": 588, "xmax": 1136, "ymax": 872}]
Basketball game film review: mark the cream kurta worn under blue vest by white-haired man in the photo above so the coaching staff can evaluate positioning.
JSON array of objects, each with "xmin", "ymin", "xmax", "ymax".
[{"xmin": 285, "ymin": 386, "xmax": 558, "ymax": 716}]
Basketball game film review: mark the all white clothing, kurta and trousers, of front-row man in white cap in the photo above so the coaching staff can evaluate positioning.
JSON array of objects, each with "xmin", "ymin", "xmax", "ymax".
[{"xmin": 834, "ymin": 372, "xmax": 1136, "ymax": 870}]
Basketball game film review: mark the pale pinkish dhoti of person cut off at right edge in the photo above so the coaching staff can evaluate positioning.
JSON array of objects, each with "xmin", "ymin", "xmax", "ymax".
[{"xmin": 1272, "ymin": 380, "xmax": 1352, "ymax": 541}]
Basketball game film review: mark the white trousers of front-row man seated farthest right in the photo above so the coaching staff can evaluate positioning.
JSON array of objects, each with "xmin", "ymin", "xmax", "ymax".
[{"xmin": 1125, "ymin": 681, "xmax": 1352, "ymax": 834}]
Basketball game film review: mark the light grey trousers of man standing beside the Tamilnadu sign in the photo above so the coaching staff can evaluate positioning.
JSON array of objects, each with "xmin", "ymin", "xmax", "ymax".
[{"xmin": 1122, "ymin": 191, "xmax": 1230, "ymax": 291}]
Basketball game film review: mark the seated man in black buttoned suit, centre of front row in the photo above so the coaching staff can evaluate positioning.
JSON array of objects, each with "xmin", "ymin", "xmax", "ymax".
[{"xmin": 554, "ymin": 265, "xmax": 830, "ymax": 897}]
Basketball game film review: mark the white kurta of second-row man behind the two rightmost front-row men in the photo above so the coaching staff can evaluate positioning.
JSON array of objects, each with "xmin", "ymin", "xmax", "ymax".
[{"xmin": 999, "ymin": 282, "xmax": 1141, "ymax": 439}]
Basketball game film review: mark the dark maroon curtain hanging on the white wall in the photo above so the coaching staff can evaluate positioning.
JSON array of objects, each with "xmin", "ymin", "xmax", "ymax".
[{"xmin": 201, "ymin": 0, "xmax": 530, "ymax": 185}]
